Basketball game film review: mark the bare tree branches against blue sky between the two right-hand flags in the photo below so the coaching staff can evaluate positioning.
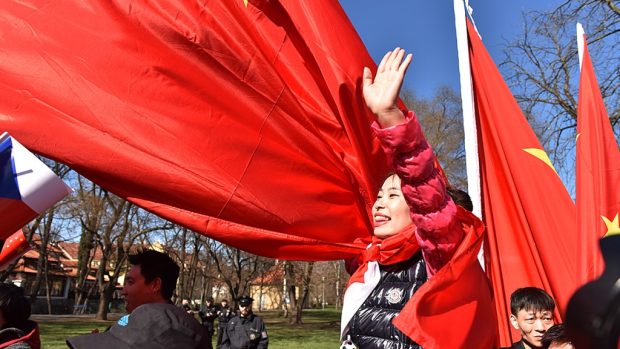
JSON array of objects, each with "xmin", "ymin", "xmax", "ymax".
[{"xmin": 500, "ymin": 0, "xmax": 620, "ymax": 182}]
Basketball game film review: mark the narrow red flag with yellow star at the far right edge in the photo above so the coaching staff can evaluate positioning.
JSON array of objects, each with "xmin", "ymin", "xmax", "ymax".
[{"xmin": 576, "ymin": 35, "xmax": 620, "ymax": 283}]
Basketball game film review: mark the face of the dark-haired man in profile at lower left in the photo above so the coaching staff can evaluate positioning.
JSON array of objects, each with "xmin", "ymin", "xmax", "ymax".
[{"xmin": 122, "ymin": 265, "xmax": 161, "ymax": 313}]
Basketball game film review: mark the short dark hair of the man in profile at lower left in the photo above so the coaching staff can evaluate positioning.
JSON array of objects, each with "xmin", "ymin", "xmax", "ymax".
[{"xmin": 129, "ymin": 250, "xmax": 180, "ymax": 299}]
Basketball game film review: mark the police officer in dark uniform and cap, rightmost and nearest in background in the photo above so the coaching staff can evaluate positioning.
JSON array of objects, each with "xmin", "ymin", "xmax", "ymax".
[{"xmin": 222, "ymin": 296, "xmax": 269, "ymax": 349}]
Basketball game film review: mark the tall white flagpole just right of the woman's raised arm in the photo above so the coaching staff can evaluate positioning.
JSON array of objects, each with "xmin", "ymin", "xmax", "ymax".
[{"xmin": 454, "ymin": 0, "xmax": 485, "ymax": 269}]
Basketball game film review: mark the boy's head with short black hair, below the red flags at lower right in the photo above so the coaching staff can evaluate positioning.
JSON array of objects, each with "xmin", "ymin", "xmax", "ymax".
[{"xmin": 505, "ymin": 287, "xmax": 555, "ymax": 349}]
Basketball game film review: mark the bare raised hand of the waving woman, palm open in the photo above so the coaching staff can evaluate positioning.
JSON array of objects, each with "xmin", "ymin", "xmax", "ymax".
[{"xmin": 363, "ymin": 47, "xmax": 413, "ymax": 127}]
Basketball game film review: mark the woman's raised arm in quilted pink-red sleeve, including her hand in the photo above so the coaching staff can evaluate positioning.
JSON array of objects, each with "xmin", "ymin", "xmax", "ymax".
[{"xmin": 363, "ymin": 48, "xmax": 463, "ymax": 275}]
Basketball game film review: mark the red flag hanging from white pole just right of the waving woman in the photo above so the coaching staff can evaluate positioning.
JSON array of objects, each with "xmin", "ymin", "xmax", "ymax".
[{"xmin": 467, "ymin": 21, "xmax": 578, "ymax": 346}]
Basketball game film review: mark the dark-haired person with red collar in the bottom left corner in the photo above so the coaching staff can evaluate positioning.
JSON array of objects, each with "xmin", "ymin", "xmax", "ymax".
[{"xmin": 0, "ymin": 283, "xmax": 41, "ymax": 349}]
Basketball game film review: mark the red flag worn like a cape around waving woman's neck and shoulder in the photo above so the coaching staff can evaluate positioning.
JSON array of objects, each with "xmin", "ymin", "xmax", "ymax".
[{"xmin": 342, "ymin": 207, "xmax": 497, "ymax": 349}]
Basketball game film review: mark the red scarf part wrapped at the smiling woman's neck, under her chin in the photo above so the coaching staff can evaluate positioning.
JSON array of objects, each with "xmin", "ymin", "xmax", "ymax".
[{"xmin": 347, "ymin": 224, "xmax": 420, "ymax": 287}]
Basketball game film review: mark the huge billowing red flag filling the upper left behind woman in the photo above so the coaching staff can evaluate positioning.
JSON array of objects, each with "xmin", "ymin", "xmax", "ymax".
[{"xmin": 0, "ymin": 0, "xmax": 386, "ymax": 260}]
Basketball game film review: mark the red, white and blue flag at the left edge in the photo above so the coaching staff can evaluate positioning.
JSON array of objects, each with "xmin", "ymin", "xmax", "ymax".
[{"xmin": 0, "ymin": 132, "xmax": 71, "ymax": 240}]
